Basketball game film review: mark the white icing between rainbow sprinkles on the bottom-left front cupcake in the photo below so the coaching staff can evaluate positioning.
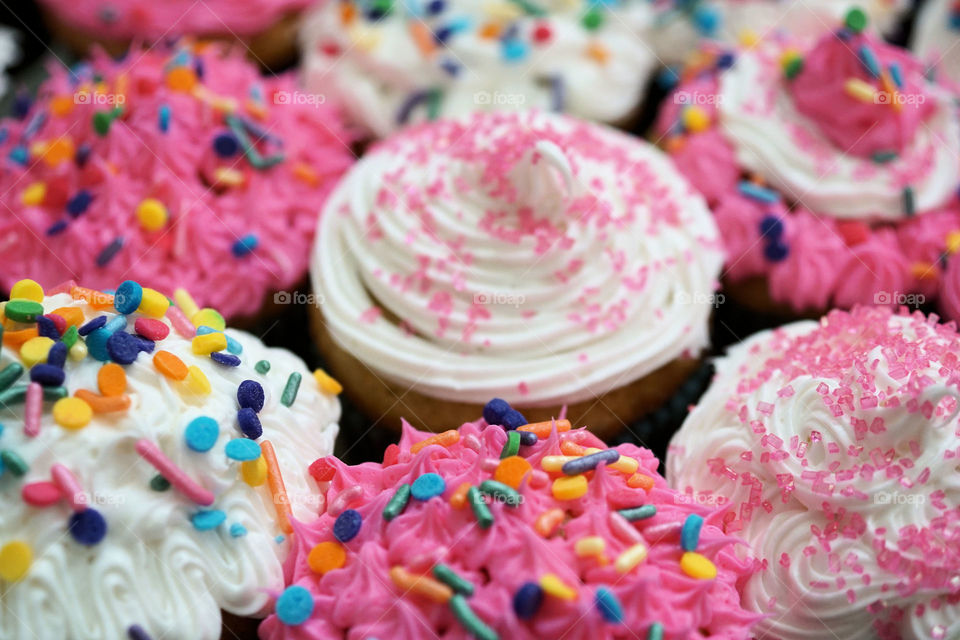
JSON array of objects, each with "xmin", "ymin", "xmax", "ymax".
[{"xmin": 0, "ymin": 294, "xmax": 340, "ymax": 640}]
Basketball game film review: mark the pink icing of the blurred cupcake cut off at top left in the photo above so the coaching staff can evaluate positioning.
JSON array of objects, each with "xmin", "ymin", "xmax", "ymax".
[{"xmin": 35, "ymin": 0, "xmax": 311, "ymax": 41}]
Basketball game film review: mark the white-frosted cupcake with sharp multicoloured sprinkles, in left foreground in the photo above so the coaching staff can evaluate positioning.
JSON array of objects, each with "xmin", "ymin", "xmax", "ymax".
[{"xmin": 0, "ymin": 280, "xmax": 340, "ymax": 640}]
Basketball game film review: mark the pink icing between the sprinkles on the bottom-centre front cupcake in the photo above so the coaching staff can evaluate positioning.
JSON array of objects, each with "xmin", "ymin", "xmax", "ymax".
[{"xmin": 260, "ymin": 421, "xmax": 758, "ymax": 640}]
